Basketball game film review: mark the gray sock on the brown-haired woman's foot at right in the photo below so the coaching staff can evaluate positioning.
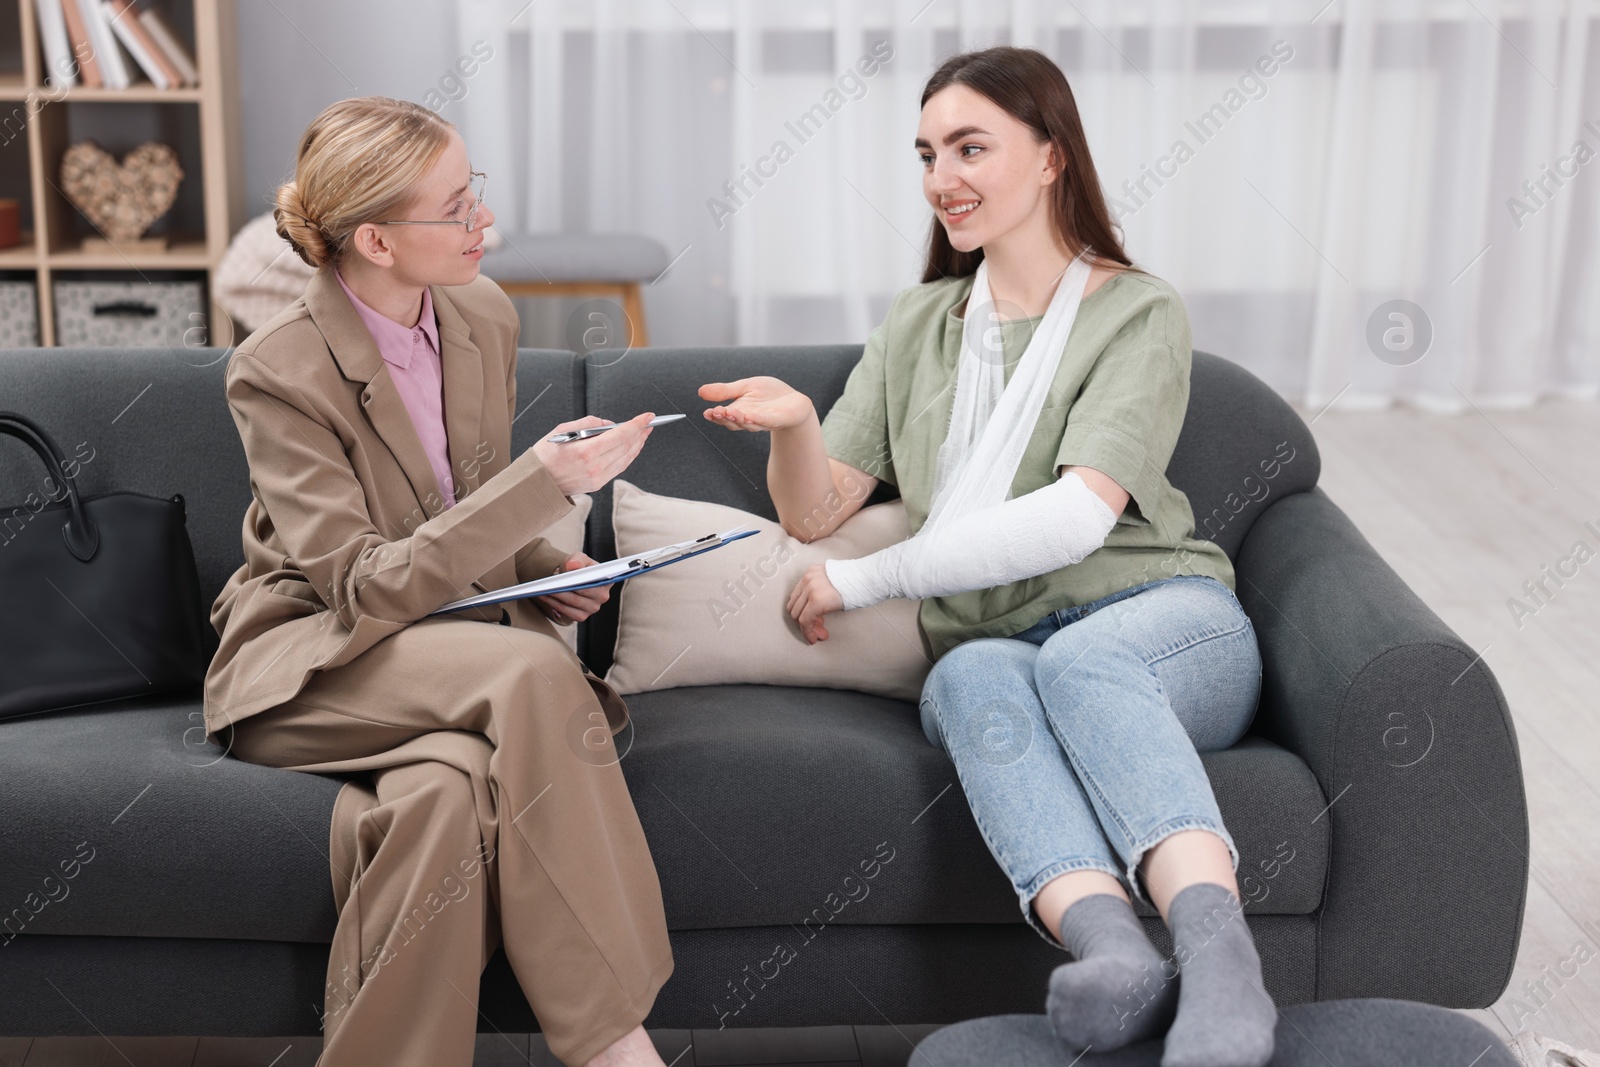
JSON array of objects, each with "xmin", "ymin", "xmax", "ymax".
[{"xmin": 1162, "ymin": 881, "xmax": 1278, "ymax": 1067}]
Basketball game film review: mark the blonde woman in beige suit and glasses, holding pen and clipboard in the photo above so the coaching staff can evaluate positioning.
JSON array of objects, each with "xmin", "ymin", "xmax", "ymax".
[{"xmin": 205, "ymin": 96, "xmax": 672, "ymax": 1067}]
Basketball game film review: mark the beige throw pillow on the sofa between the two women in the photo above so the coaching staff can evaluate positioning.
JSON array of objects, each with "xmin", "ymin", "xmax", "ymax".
[{"xmin": 605, "ymin": 478, "xmax": 933, "ymax": 702}]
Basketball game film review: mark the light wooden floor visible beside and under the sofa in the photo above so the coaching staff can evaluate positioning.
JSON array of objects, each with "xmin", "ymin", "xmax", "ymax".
[{"xmin": 0, "ymin": 402, "xmax": 1600, "ymax": 1067}]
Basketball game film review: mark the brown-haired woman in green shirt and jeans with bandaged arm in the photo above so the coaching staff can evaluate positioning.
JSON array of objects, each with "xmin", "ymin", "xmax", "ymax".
[{"xmin": 701, "ymin": 48, "xmax": 1277, "ymax": 1067}]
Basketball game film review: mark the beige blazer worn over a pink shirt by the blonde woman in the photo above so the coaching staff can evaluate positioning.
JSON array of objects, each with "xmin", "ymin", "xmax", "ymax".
[{"xmin": 205, "ymin": 267, "xmax": 627, "ymax": 737}]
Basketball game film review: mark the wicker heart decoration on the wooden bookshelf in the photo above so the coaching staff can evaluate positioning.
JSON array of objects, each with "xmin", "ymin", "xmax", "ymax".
[{"xmin": 61, "ymin": 141, "xmax": 184, "ymax": 242}]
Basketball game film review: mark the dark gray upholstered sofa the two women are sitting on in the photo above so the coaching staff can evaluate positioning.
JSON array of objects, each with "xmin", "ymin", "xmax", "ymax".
[{"xmin": 0, "ymin": 346, "xmax": 1528, "ymax": 1035}]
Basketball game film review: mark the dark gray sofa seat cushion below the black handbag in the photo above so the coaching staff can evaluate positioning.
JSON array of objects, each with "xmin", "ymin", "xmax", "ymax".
[{"xmin": 0, "ymin": 691, "xmax": 341, "ymax": 942}]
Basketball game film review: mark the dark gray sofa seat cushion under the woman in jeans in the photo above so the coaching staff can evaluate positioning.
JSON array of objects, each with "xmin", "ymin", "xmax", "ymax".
[{"xmin": 616, "ymin": 685, "xmax": 1330, "ymax": 929}]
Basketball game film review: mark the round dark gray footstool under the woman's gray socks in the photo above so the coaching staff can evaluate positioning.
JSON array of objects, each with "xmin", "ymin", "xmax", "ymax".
[{"xmin": 907, "ymin": 998, "xmax": 1518, "ymax": 1067}]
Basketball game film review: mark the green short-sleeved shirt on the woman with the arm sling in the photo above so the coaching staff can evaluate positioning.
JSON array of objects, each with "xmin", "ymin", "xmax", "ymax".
[{"xmin": 822, "ymin": 270, "xmax": 1234, "ymax": 657}]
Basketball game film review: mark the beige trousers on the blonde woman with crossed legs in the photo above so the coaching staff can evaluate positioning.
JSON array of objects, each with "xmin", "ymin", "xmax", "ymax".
[{"xmin": 232, "ymin": 617, "xmax": 672, "ymax": 1067}]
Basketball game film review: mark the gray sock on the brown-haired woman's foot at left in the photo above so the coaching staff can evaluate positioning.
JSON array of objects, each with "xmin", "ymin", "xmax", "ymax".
[{"xmin": 1045, "ymin": 893, "xmax": 1178, "ymax": 1053}]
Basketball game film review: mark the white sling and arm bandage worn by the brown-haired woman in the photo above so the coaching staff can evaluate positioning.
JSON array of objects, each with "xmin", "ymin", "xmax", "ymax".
[{"xmin": 824, "ymin": 254, "xmax": 1117, "ymax": 611}]
